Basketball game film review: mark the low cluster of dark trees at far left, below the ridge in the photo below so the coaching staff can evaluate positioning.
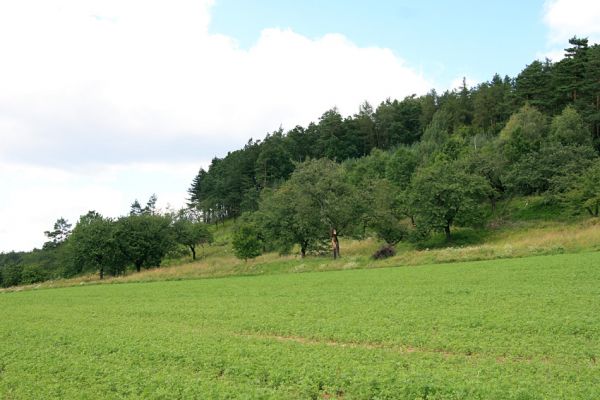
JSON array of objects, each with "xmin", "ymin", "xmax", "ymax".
[{"xmin": 0, "ymin": 196, "xmax": 212, "ymax": 287}]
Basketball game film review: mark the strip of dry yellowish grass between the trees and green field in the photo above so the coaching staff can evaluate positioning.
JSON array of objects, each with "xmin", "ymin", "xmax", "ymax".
[{"xmin": 0, "ymin": 197, "xmax": 600, "ymax": 292}]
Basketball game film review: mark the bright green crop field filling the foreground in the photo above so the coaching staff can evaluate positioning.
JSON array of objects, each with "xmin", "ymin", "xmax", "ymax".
[{"xmin": 0, "ymin": 252, "xmax": 600, "ymax": 399}]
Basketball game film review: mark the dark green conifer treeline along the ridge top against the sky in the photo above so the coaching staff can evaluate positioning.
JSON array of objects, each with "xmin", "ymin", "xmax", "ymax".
[{"xmin": 189, "ymin": 37, "xmax": 600, "ymax": 223}]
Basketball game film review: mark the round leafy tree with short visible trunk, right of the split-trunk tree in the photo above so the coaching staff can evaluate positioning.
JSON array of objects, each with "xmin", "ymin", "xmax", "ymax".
[{"xmin": 409, "ymin": 159, "xmax": 489, "ymax": 241}]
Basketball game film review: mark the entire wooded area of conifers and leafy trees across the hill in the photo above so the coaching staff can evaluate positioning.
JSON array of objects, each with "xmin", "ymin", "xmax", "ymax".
[{"xmin": 0, "ymin": 37, "xmax": 600, "ymax": 287}]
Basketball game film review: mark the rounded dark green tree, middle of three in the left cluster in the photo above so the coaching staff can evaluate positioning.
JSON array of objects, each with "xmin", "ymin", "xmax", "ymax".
[{"xmin": 115, "ymin": 214, "xmax": 174, "ymax": 272}]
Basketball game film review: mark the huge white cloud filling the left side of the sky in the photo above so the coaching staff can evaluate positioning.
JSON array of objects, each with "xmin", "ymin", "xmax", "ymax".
[{"xmin": 0, "ymin": 0, "xmax": 433, "ymax": 251}]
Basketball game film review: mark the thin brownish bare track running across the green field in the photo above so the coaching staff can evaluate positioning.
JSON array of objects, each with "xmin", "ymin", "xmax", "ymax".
[{"xmin": 233, "ymin": 333, "xmax": 552, "ymax": 364}]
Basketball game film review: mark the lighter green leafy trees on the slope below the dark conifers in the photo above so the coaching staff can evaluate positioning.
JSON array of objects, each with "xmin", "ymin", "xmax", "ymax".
[{"xmin": 233, "ymin": 101, "xmax": 600, "ymax": 258}]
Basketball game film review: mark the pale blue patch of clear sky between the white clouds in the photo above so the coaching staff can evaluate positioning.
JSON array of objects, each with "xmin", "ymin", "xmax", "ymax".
[{"xmin": 210, "ymin": 0, "xmax": 548, "ymax": 88}]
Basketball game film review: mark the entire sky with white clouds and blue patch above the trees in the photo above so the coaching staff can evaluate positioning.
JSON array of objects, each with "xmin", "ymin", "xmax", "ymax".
[{"xmin": 0, "ymin": 0, "xmax": 600, "ymax": 252}]
